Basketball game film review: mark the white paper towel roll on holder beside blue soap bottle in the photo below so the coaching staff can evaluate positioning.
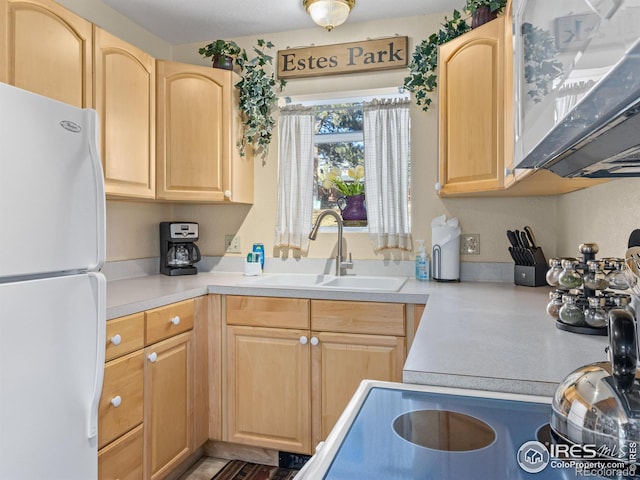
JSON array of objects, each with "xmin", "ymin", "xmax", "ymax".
[{"xmin": 431, "ymin": 215, "xmax": 461, "ymax": 281}]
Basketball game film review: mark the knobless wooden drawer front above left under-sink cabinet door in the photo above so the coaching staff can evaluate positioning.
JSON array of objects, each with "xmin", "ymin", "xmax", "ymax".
[{"xmin": 225, "ymin": 295, "xmax": 309, "ymax": 329}]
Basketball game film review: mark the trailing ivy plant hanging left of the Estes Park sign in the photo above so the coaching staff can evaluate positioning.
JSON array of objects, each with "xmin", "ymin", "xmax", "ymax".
[{"xmin": 198, "ymin": 39, "xmax": 286, "ymax": 157}]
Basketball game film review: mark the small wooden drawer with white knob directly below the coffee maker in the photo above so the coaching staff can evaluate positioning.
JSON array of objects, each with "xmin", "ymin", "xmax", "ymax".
[{"xmin": 145, "ymin": 300, "xmax": 194, "ymax": 345}]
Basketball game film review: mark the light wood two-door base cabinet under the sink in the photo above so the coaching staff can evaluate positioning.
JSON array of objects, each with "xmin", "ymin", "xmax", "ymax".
[{"xmin": 223, "ymin": 296, "xmax": 406, "ymax": 453}]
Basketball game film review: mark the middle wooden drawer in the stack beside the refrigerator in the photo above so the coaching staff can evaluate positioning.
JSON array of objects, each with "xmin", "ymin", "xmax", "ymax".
[{"xmin": 98, "ymin": 350, "xmax": 144, "ymax": 448}]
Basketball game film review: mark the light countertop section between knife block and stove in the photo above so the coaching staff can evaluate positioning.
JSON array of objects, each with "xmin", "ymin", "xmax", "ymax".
[{"xmin": 403, "ymin": 283, "xmax": 607, "ymax": 396}]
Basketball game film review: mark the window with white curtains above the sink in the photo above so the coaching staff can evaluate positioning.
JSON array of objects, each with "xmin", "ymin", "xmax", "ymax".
[{"xmin": 276, "ymin": 89, "xmax": 412, "ymax": 252}]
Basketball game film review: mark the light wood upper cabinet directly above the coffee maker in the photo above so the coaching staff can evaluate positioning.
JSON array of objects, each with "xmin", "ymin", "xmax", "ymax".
[{"xmin": 156, "ymin": 61, "xmax": 253, "ymax": 203}]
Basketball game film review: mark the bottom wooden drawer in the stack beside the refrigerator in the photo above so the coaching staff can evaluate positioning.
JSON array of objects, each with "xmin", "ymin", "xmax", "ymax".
[{"xmin": 98, "ymin": 425, "xmax": 144, "ymax": 480}]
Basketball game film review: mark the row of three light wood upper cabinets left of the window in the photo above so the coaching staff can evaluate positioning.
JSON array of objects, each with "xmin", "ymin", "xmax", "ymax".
[{"xmin": 0, "ymin": 0, "xmax": 253, "ymax": 204}]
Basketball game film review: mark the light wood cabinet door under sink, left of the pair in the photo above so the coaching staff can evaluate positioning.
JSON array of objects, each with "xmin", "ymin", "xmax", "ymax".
[{"xmin": 224, "ymin": 326, "xmax": 311, "ymax": 453}]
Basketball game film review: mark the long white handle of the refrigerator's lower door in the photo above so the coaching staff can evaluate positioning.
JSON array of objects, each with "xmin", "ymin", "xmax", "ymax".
[{"xmin": 87, "ymin": 272, "xmax": 107, "ymax": 440}]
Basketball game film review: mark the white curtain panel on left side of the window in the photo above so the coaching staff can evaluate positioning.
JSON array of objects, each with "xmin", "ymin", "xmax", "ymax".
[{"xmin": 275, "ymin": 105, "xmax": 315, "ymax": 253}]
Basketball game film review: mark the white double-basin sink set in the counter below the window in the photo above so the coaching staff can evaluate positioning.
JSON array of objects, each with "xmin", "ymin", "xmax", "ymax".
[{"xmin": 242, "ymin": 273, "xmax": 407, "ymax": 292}]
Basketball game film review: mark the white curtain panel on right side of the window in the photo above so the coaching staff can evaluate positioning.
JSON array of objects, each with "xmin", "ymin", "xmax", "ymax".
[{"xmin": 363, "ymin": 99, "xmax": 412, "ymax": 252}]
